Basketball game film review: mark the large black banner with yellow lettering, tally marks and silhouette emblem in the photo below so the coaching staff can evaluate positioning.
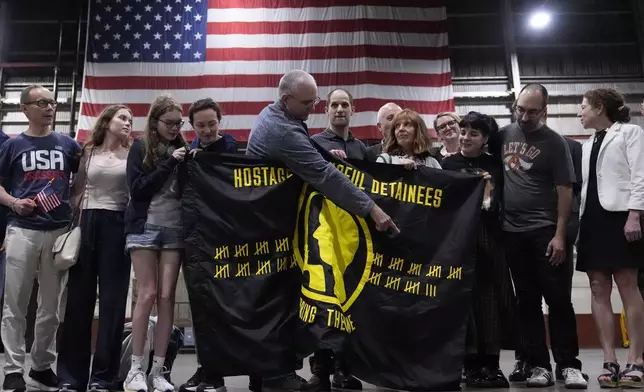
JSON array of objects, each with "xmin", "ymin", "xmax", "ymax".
[{"xmin": 182, "ymin": 153, "xmax": 483, "ymax": 390}]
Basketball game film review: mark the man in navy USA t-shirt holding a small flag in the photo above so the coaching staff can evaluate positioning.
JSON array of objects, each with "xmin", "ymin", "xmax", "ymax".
[{"xmin": 0, "ymin": 86, "xmax": 81, "ymax": 392}]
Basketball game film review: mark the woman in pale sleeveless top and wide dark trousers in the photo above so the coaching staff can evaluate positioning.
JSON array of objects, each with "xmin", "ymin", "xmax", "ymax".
[{"xmin": 57, "ymin": 105, "xmax": 132, "ymax": 391}]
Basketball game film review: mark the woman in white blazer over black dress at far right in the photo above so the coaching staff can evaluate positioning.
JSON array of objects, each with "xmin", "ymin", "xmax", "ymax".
[{"xmin": 577, "ymin": 89, "xmax": 644, "ymax": 388}]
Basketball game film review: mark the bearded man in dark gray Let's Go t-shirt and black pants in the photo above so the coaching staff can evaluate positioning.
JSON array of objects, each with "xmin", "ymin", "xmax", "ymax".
[{"xmin": 501, "ymin": 85, "xmax": 587, "ymax": 388}]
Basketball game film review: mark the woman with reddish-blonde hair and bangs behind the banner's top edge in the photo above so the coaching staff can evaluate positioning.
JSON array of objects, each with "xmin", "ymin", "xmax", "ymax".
[{"xmin": 376, "ymin": 109, "xmax": 441, "ymax": 169}]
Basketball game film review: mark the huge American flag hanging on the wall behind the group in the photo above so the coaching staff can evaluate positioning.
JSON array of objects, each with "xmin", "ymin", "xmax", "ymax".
[{"xmin": 77, "ymin": 0, "xmax": 454, "ymax": 142}]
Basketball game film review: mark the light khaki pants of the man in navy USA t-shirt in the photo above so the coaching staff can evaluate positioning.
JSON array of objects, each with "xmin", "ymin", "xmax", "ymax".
[{"xmin": 1, "ymin": 226, "xmax": 67, "ymax": 374}]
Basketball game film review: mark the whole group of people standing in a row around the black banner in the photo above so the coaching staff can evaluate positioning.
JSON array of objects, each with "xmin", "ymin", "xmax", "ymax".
[{"xmin": 0, "ymin": 70, "xmax": 644, "ymax": 392}]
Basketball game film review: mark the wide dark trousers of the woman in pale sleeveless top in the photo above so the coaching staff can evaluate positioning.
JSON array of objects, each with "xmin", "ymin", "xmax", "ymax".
[{"xmin": 57, "ymin": 210, "xmax": 131, "ymax": 391}]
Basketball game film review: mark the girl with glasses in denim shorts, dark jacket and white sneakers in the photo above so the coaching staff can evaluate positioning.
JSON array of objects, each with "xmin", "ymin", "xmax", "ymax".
[{"xmin": 123, "ymin": 96, "xmax": 187, "ymax": 392}]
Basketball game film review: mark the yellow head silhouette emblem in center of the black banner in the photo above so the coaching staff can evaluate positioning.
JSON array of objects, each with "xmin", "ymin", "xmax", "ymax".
[{"xmin": 293, "ymin": 187, "xmax": 373, "ymax": 311}]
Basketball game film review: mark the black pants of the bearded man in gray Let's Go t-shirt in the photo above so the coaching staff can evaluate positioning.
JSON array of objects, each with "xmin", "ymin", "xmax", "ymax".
[{"xmin": 505, "ymin": 226, "xmax": 581, "ymax": 370}]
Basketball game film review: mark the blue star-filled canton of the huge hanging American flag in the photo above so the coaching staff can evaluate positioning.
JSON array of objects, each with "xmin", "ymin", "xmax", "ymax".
[{"xmin": 88, "ymin": 0, "xmax": 208, "ymax": 63}]
